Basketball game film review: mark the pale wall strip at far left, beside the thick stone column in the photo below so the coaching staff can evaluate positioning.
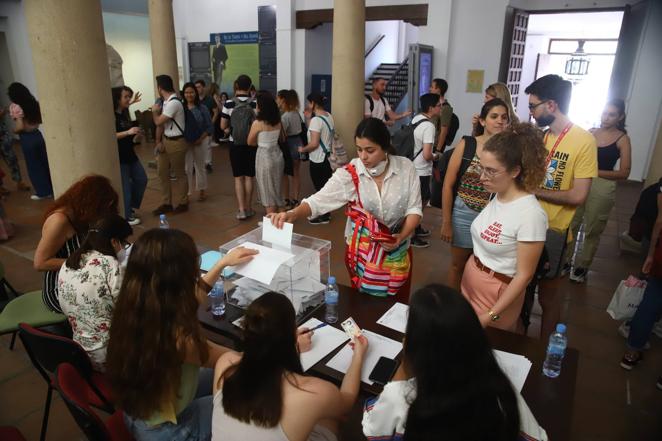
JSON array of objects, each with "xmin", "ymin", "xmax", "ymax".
[{"xmin": 0, "ymin": 1, "xmax": 39, "ymax": 98}]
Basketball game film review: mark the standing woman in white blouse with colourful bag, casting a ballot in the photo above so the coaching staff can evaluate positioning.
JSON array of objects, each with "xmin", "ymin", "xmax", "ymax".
[{"xmin": 271, "ymin": 118, "xmax": 423, "ymax": 302}]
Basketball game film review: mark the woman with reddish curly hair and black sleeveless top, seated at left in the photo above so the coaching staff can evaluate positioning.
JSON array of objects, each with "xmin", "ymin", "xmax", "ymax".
[{"xmin": 34, "ymin": 175, "xmax": 119, "ymax": 312}]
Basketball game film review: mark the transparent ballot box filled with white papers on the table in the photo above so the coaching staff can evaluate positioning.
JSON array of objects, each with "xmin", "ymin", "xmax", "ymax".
[{"xmin": 219, "ymin": 227, "xmax": 331, "ymax": 316}]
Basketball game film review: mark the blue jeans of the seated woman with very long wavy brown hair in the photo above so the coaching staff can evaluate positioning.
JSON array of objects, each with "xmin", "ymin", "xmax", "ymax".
[{"xmin": 124, "ymin": 368, "xmax": 214, "ymax": 441}]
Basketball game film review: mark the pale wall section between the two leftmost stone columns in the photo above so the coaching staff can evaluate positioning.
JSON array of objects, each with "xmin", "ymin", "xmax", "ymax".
[{"xmin": 103, "ymin": 12, "xmax": 155, "ymax": 112}]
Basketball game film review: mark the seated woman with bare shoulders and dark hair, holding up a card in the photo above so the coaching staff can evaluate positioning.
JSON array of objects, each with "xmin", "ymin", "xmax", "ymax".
[{"xmin": 212, "ymin": 292, "xmax": 368, "ymax": 441}]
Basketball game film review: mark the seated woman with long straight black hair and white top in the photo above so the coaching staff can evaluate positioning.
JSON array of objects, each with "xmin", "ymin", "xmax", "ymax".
[{"xmin": 362, "ymin": 285, "xmax": 547, "ymax": 441}]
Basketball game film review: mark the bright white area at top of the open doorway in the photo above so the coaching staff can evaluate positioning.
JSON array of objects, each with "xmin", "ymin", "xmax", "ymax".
[{"xmin": 527, "ymin": 11, "xmax": 623, "ymax": 38}]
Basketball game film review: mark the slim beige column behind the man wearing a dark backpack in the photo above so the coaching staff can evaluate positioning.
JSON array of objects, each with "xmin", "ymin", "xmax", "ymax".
[{"xmin": 147, "ymin": 0, "xmax": 179, "ymax": 89}]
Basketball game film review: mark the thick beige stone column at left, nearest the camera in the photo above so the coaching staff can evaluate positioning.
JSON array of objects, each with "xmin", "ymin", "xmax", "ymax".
[{"xmin": 24, "ymin": 0, "xmax": 122, "ymax": 200}]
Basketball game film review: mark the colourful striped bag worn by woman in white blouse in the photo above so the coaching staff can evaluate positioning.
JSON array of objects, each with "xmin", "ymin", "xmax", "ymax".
[{"xmin": 345, "ymin": 164, "xmax": 411, "ymax": 297}]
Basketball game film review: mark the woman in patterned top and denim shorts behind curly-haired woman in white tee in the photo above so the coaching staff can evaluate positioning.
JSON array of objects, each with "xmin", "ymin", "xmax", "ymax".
[{"xmin": 441, "ymin": 98, "xmax": 509, "ymax": 290}]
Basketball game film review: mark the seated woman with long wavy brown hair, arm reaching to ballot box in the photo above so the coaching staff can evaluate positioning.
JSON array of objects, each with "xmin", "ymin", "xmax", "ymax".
[{"xmin": 106, "ymin": 229, "xmax": 256, "ymax": 441}]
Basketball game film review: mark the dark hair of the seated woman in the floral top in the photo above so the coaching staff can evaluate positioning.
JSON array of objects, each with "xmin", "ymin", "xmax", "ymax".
[{"xmin": 66, "ymin": 214, "xmax": 133, "ymax": 270}]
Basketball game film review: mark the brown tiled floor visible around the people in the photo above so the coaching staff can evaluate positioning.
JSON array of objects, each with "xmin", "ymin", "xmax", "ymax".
[{"xmin": 0, "ymin": 146, "xmax": 662, "ymax": 441}]
